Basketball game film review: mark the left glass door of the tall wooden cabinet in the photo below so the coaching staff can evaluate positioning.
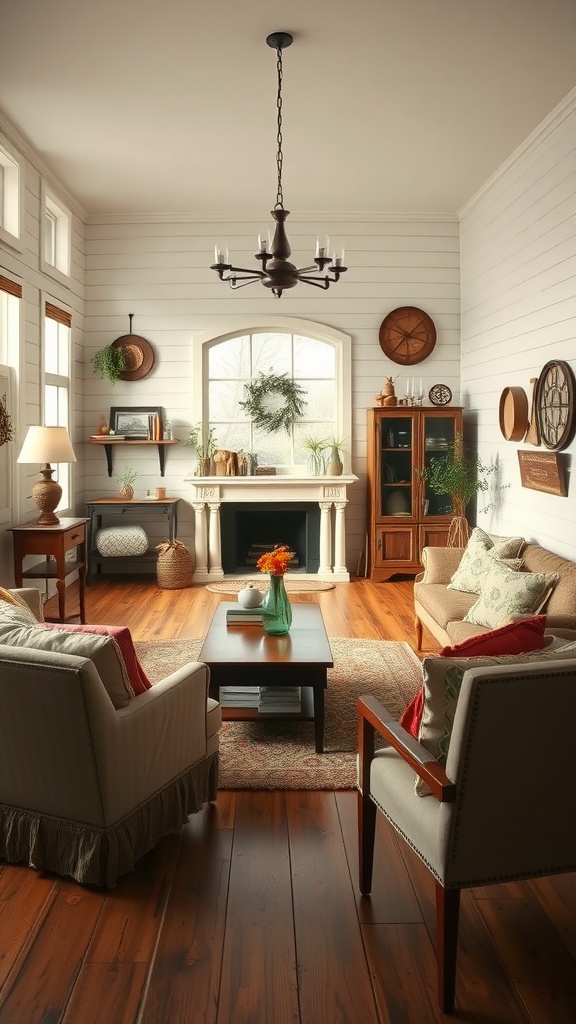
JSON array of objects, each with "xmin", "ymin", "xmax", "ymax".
[{"xmin": 379, "ymin": 412, "xmax": 412, "ymax": 519}]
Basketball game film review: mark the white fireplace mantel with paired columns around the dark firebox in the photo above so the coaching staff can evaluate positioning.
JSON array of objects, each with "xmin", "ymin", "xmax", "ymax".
[{"xmin": 186, "ymin": 473, "xmax": 358, "ymax": 583}]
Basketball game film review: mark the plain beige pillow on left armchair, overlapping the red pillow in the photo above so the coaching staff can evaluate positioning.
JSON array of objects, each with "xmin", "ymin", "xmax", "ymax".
[{"xmin": 0, "ymin": 623, "xmax": 134, "ymax": 708}]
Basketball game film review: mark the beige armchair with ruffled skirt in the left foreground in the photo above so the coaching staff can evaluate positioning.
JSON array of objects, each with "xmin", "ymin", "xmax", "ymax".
[{"xmin": 0, "ymin": 591, "xmax": 220, "ymax": 887}]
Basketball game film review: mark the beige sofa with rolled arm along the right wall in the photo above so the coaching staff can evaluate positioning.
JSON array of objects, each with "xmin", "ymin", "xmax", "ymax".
[{"xmin": 414, "ymin": 544, "xmax": 576, "ymax": 650}]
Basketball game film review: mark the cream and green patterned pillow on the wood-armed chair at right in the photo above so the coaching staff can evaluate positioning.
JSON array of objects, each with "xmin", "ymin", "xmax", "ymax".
[{"xmin": 416, "ymin": 637, "xmax": 576, "ymax": 797}]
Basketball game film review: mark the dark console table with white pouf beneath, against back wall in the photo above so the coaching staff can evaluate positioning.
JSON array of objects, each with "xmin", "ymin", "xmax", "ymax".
[{"xmin": 86, "ymin": 497, "xmax": 179, "ymax": 584}]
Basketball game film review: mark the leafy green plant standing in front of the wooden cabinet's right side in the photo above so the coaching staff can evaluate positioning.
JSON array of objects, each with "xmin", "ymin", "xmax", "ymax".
[{"xmin": 420, "ymin": 434, "xmax": 497, "ymax": 548}]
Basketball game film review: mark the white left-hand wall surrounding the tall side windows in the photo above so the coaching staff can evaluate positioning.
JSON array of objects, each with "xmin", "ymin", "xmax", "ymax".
[{"xmin": 0, "ymin": 116, "xmax": 85, "ymax": 583}]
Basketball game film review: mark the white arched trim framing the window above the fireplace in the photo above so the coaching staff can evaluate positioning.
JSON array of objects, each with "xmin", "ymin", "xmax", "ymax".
[{"xmin": 192, "ymin": 316, "xmax": 353, "ymax": 457}]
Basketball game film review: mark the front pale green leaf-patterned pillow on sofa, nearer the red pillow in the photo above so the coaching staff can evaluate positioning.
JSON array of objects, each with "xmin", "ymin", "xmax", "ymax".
[{"xmin": 464, "ymin": 562, "xmax": 559, "ymax": 628}]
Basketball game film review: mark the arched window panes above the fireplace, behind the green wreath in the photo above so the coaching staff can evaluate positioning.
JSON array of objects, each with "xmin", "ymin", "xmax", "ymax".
[{"xmin": 205, "ymin": 331, "xmax": 342, "ymax": 465}]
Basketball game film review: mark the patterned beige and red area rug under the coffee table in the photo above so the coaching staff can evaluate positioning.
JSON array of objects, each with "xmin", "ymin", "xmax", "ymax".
[{"xmin": 136, "ymin": 637, "xmax": 421, "ymax": 790}]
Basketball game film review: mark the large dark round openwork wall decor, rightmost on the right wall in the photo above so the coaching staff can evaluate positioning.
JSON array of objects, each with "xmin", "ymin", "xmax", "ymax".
[{"xmin": 534, "ymin": 359, "xmax": 576, "ymax": 452}]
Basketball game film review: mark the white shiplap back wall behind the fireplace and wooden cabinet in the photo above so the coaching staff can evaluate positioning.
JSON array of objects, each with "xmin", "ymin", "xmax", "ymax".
[{"xmin": 84, "ymin": 215, "xmax": 460, "ymax": 572}]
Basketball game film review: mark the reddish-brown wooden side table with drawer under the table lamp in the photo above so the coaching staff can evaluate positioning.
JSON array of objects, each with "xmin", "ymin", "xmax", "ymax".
[{"xmin": 11, "ymin": 517, "xmax": 88, "ymax": 623}]
